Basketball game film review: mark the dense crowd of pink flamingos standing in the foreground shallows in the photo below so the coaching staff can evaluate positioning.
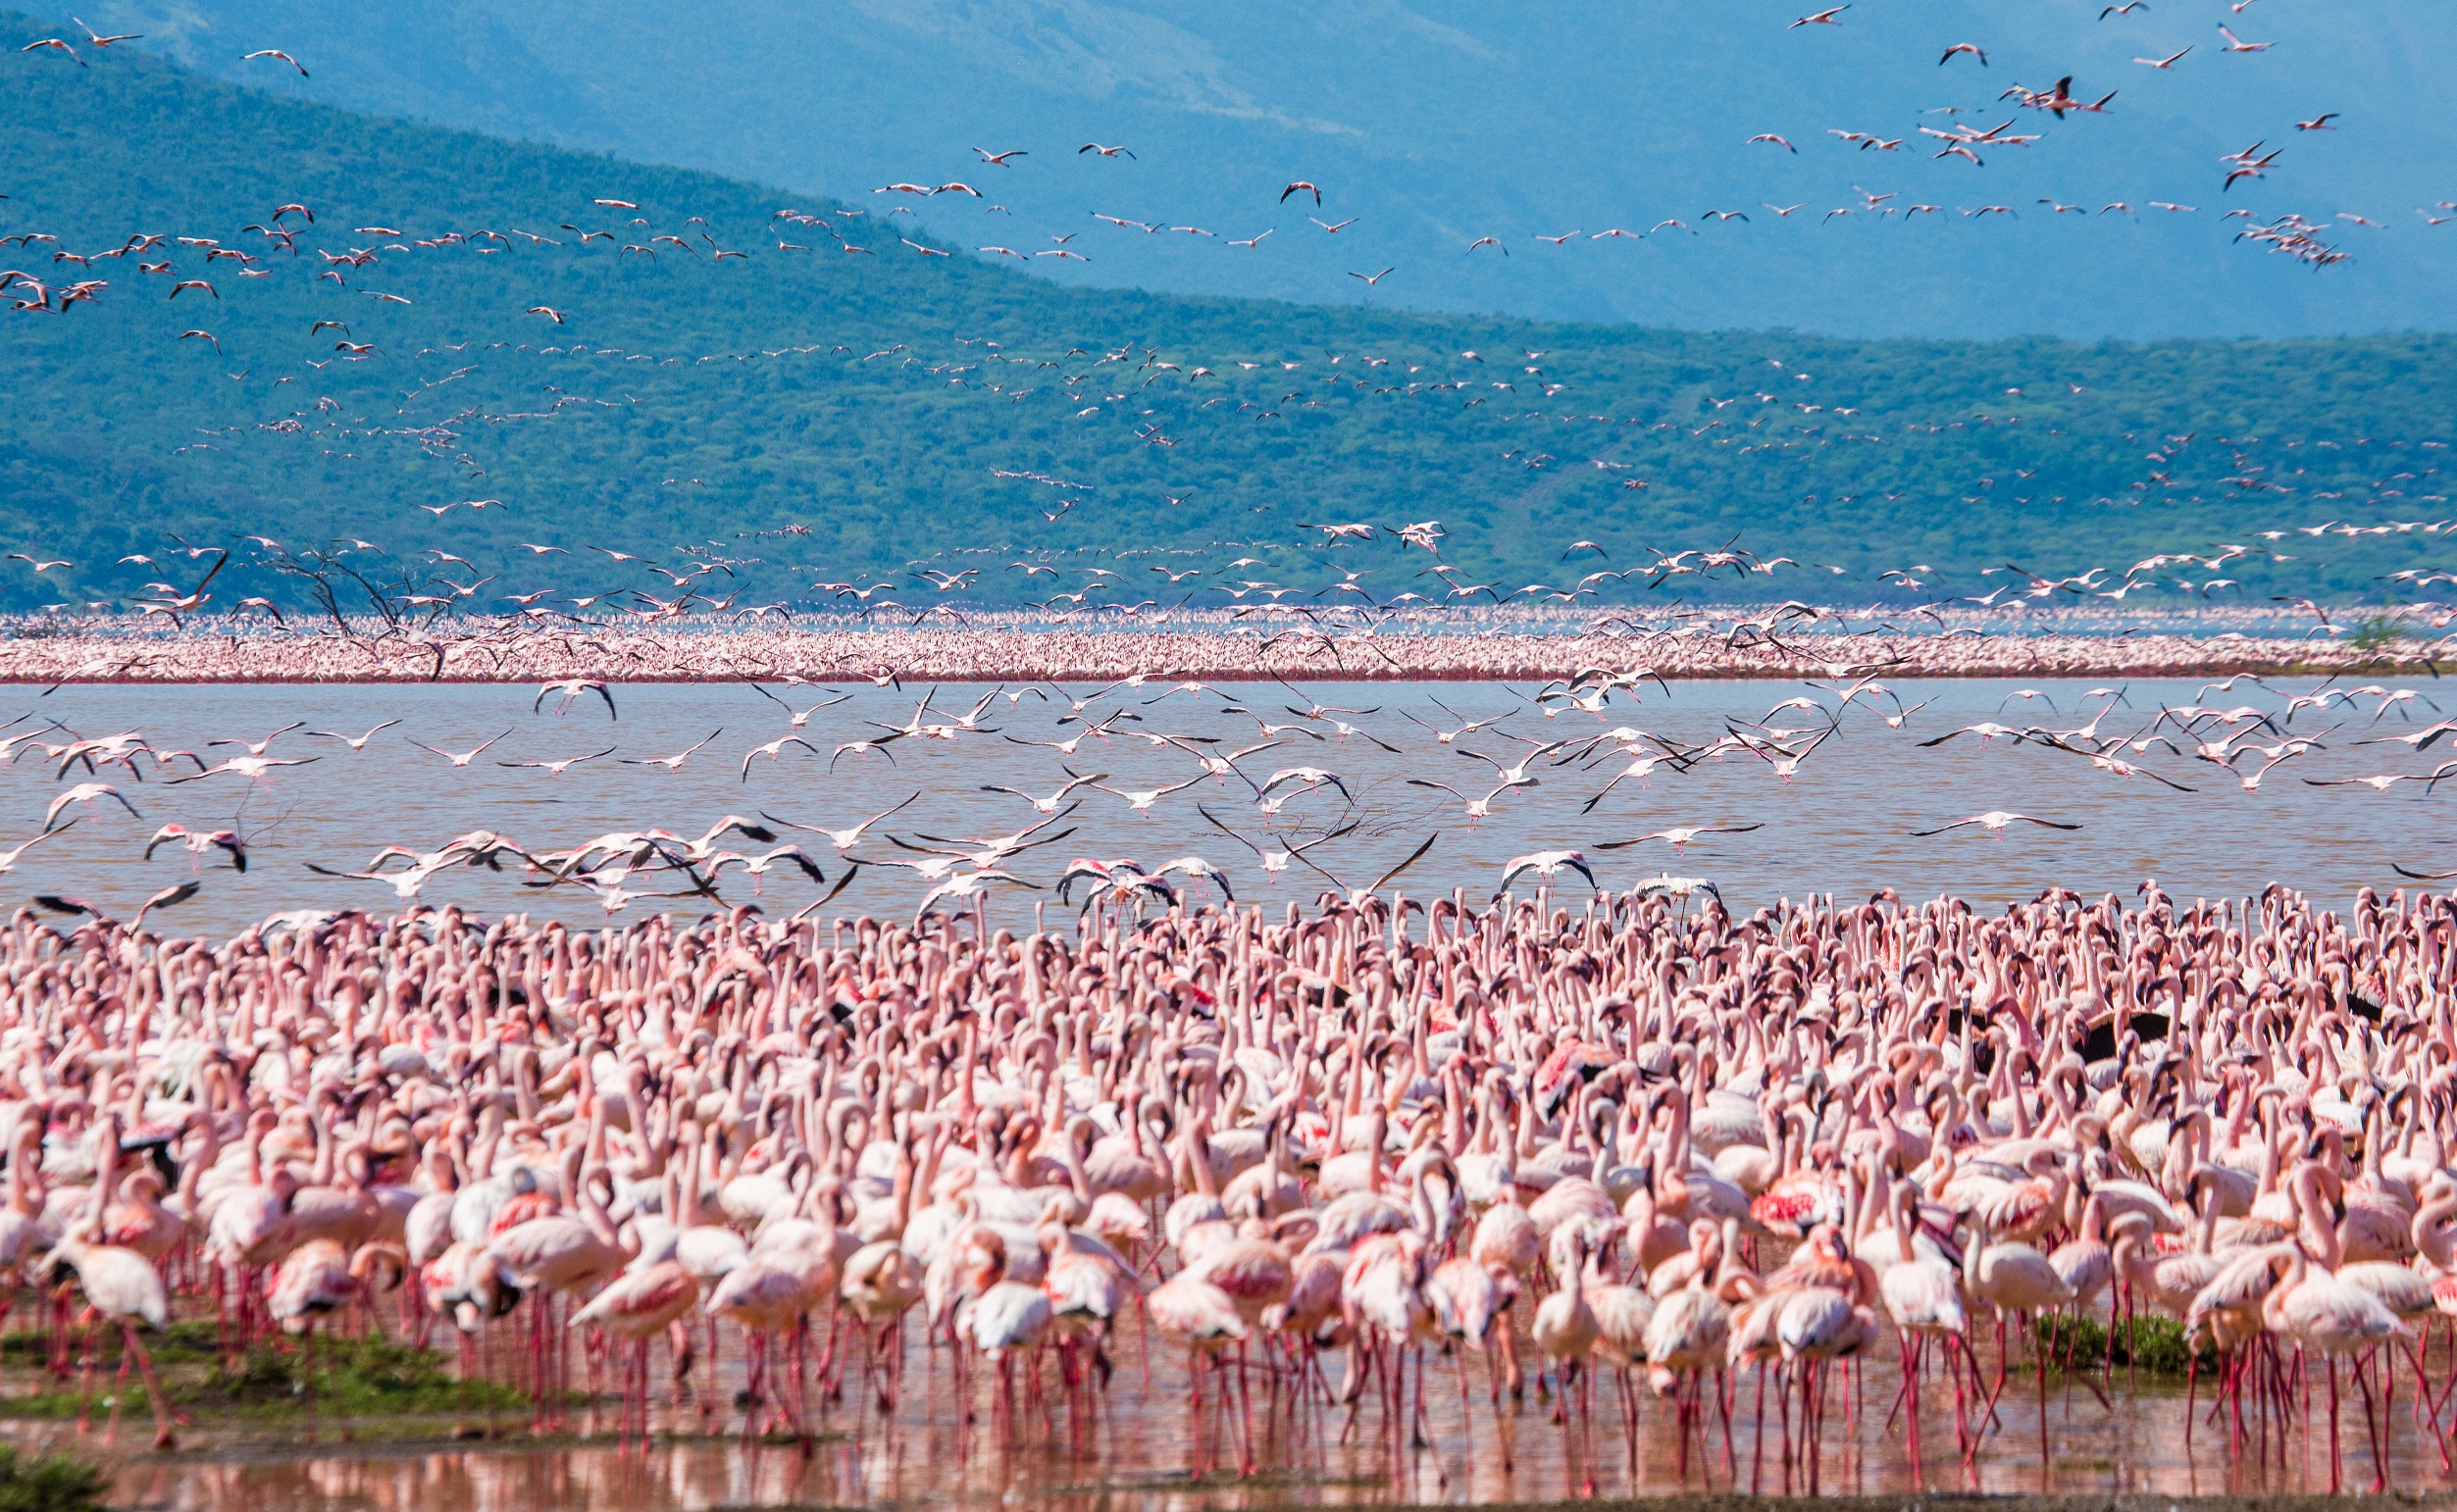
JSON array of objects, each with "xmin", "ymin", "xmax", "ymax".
[{"xmin": 0, "ymin": 883, "xmax": 2457, "ymax": 1489}]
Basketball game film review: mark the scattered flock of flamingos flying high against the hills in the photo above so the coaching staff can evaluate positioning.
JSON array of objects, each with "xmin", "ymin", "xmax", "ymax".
[{"xmin": 0, "ymin": 8, "xmax": 2447, "ymax": 633}]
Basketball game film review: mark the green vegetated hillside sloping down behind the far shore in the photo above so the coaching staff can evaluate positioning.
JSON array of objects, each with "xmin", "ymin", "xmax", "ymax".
[{"xmin": 0, "ymin": 18, "xmax": 2457, "ymax": 621}]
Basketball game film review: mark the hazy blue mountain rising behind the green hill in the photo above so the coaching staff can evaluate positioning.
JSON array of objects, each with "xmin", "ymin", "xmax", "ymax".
[{"xmin": 52, "ymin": 0, "xmax": 2457, "ymax": 338}]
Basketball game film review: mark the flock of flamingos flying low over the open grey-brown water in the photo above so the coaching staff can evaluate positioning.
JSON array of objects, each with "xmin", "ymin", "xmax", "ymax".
[{"xmin": 0, "ymin": 663, "xmax": 2457, "ymax": 923}]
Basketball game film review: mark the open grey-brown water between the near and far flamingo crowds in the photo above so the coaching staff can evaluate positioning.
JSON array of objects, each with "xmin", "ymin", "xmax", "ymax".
[{"xmin": 0, "ymin": 680, "xmax": 2427, "ymax": 935}]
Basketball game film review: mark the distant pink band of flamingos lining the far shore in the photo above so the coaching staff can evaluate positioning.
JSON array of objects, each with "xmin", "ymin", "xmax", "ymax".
[{"xmin": 0, "ymin": 609, "xmax": 2397, "ymax": 684}]
